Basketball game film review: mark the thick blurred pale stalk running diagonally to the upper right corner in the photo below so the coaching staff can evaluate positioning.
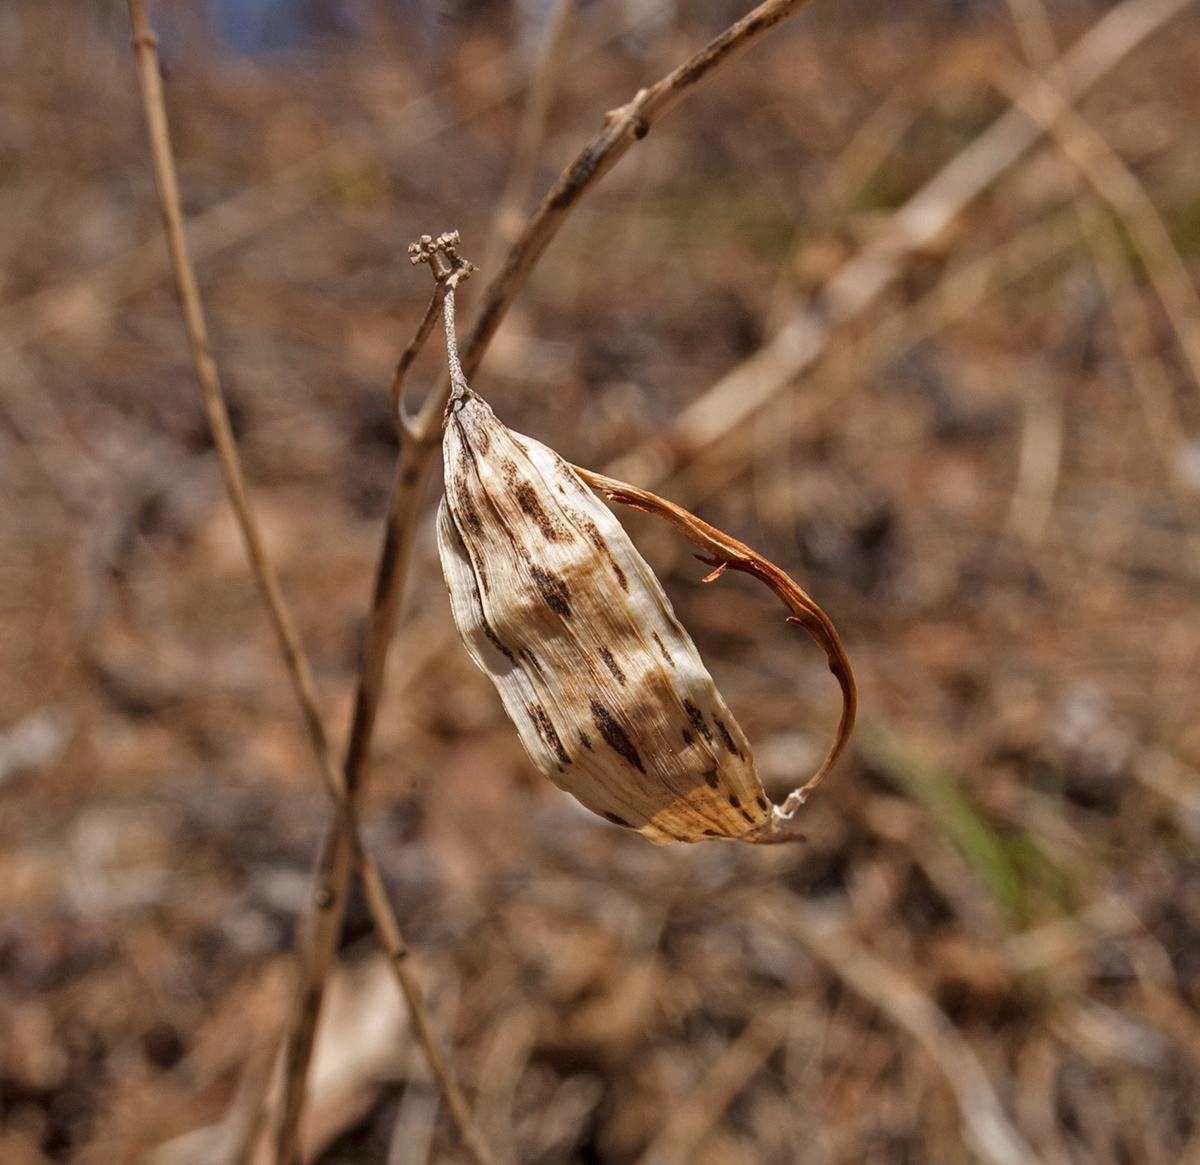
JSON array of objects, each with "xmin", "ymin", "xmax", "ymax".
[{"xmin": 608, "ymin": 0, "xmax": 1190, "ymax": 487}]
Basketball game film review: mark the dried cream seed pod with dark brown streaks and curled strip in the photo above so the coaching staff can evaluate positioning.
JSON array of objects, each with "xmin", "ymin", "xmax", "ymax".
[{"xmin": 427, "ymin": 235, "xmax": 854, "ymax": 845}]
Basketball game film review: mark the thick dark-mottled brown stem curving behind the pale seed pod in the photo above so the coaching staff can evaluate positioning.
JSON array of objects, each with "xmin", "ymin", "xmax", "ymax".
[{"xmin": 274, "ymin": 0, "xmax": 809, "ymax": 1142}]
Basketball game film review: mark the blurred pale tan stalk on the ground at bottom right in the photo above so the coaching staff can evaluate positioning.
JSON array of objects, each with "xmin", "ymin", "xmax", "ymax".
[{"xmin": 756, "ymin": 895, "xmax": 1042, "ymax": 1165}]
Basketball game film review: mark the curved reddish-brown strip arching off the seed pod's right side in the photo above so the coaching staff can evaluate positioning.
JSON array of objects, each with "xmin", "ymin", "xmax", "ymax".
[{"xmin": 572, "ymin": 466, "xmax": 858, "ymax": 816}]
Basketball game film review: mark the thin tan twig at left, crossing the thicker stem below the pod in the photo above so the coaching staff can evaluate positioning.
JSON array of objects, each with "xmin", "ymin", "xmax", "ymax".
[{"xmin": 128, "ymin": 9, "xmax": 488, "ymax": 1165}]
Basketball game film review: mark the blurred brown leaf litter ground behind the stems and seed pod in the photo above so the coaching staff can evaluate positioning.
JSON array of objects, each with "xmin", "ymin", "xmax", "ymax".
[{"xmin": 0, "ymin": 0, "xmax": 1200, "ymax": 1165}]
